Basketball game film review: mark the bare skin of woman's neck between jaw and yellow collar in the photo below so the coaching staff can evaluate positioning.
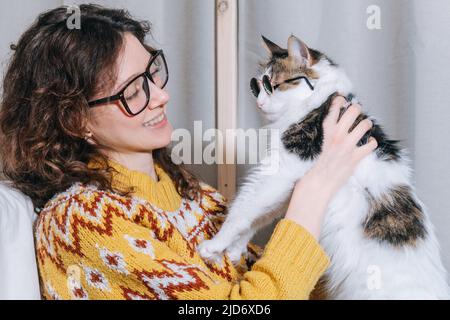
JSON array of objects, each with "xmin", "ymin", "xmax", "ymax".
[{"xmin": 108, "ymin": 152, "xmax": 158, "ymax": 181}]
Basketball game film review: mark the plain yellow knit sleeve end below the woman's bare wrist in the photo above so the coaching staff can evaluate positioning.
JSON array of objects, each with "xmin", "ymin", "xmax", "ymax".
[{"xmin": 229, "ymin": 219, "xmax": 329, "ymax": 299}]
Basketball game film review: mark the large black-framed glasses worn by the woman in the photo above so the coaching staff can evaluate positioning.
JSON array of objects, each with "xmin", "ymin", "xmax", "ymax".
[{"xmin": 89, "ymin": 50, "xmax": 169, "ymax": 116}]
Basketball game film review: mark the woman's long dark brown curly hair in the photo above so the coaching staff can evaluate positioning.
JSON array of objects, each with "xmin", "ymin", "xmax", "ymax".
[{"xmin": 0, "ymin": 5, "xmax": 199, "ymax": 211}]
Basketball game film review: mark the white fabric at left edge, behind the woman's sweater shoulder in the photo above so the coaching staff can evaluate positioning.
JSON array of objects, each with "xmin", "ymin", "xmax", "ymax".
[{"xmin": 0, "ymin": 183, "xmax": 40, "ymax": 300}]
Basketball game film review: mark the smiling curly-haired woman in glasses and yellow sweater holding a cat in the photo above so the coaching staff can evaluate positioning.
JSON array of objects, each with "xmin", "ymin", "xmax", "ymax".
[{"xmin": 0, "ymin": 5, "xmax": 376, "ymax": 299}]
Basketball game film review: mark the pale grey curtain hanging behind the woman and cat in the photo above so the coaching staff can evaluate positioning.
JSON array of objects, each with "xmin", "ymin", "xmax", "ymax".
[{"xmin": 0, "ymin": 0, "xmax": 450, "ymax": 270}]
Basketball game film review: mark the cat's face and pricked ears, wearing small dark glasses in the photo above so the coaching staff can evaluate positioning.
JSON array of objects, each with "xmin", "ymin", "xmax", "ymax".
[{"xmin": 253, "ymin": 36, "xmax": 319, "ymax": 121}]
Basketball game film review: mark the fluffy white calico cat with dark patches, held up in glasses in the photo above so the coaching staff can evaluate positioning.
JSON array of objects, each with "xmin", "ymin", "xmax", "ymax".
[{"xmin": 198, "ymin": 36, "xmax": 449, "ymax": 299}]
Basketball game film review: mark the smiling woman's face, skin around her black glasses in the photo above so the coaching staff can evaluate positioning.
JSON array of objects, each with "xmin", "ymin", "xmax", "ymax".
[{"xmin": 88, "ymin": 33, "xmax": 172, "ymax": 154}]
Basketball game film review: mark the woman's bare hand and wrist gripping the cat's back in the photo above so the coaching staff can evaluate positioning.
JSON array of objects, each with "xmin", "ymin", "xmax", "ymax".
[{"xmin": 285, "ymin": 96, "xmax": 377, "ymax": 238}]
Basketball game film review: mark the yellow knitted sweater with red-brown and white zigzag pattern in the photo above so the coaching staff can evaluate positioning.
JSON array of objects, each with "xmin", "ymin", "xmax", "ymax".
[{"xmin": 35, "ymin": 162, "xmax": 329, "ymax": 299}]
